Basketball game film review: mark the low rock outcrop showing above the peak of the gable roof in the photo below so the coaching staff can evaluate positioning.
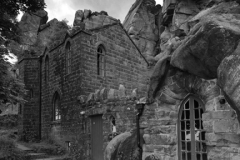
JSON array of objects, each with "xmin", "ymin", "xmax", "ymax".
[{"xmin": 73, "ymin": 9, "xmax": 118, "ymax": 29}]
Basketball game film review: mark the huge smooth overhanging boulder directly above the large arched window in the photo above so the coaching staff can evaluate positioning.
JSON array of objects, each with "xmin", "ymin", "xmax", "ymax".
[{"xmin": 171, "ymin": 2, "xmax": 240, "ymax": 79}]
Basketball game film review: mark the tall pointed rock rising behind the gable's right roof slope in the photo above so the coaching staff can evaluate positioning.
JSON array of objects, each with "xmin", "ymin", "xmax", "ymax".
[{"xmin": 123, "ymin": 0, "xmax": 161, "ymax": 59}]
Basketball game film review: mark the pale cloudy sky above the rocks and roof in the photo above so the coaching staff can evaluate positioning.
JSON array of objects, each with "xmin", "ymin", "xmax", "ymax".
[{"xmin": 42, "ymin": 0, "xmax": 163, "ymax": 25}]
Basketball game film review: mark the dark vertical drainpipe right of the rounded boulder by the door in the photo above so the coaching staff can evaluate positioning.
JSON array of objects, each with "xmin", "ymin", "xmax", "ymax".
[{"xmin": 136, "ymin": 103, "xmax": 145, "ymax": 160}]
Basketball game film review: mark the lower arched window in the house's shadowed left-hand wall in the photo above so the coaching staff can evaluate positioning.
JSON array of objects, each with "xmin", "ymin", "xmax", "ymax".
[{"xmin": 53, "ymin": 93, "xmax": 61, "ymax": 121}]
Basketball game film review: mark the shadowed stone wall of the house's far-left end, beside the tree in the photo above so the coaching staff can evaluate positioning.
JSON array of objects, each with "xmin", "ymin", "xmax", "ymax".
[{"xmin": 18, "ymin": 58, "xmax": 40, "ymax": 141}]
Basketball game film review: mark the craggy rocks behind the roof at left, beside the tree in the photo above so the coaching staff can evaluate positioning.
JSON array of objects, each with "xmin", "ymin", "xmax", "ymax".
[{"xmin": 19, "ymin": 10, "xmax": 68, "ymax": 57}]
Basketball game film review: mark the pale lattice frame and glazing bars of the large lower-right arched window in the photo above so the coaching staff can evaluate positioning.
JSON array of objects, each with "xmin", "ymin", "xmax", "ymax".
[{"xmin": 177, "ymin": 94, "xmax": 207, "ymax": 160}]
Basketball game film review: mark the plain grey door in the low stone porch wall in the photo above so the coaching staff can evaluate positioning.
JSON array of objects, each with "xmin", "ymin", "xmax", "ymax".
[{"xmin": 91, "ymin": 115, "xmax": 103, "ymax": 160}]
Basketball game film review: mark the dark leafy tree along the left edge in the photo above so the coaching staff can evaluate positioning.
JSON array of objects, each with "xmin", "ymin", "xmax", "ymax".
[{"xmin": 0, "ymin": 0, "xmax": 45, "ymax": 104}]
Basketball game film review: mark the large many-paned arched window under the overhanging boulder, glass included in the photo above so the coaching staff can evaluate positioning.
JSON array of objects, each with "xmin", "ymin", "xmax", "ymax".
[{"xmin": 178, "ymin": 95, "xmax": 207, "ymax": 160}]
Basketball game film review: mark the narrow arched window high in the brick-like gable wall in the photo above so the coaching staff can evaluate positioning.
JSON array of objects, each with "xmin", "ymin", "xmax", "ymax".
[{"xmin": 97, "ymin": 45, "xmax": 105, "ymax": 76}]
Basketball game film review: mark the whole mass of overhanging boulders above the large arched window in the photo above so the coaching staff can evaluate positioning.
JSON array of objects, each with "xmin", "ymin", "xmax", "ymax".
[{"xmin": 148, "ymin": 2, "xmax": 240, "ymax": 109}]
